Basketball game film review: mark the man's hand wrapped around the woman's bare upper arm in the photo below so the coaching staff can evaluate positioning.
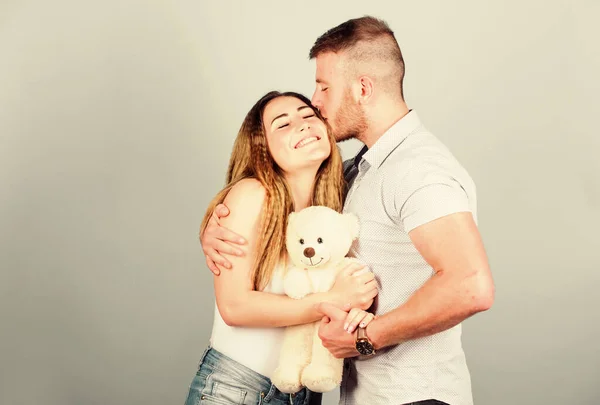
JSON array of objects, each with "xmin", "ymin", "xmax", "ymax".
[{"xmin": 199, "ymin": 204, "xmax": 246, "ymax": 276}]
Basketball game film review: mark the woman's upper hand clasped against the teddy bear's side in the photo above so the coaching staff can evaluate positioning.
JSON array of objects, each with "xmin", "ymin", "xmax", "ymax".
[{"xmin": 329, "ymin": 261, "xmax": 378, "ymax": 311}]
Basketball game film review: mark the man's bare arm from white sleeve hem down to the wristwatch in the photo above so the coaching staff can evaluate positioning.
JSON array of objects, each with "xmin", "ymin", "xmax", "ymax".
[{"xmin": 367, "ymin": 212, "xmax": 494, "ymax": 349}]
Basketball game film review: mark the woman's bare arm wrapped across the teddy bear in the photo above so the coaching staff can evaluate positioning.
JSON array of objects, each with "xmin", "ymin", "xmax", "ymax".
[{"xmin": 209, "ymin": 179, "xmax": 376, "ymax": 327}]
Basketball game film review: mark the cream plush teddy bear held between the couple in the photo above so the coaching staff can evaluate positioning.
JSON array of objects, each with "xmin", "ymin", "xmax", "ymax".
[{"xmin": 271, "ymin": 206, "xmax": 359, "ymax": 393}]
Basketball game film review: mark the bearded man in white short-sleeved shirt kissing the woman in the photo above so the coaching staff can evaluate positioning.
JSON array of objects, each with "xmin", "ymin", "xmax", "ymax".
[{"xmin": 201, "ymin": 17, "xmax": 494, "ymax": 405}]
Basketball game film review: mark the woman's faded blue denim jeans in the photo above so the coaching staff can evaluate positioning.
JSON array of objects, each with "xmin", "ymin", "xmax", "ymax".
[{"xmin": 185, "ymin": 347, "xmax": 322, "ymax": 405}]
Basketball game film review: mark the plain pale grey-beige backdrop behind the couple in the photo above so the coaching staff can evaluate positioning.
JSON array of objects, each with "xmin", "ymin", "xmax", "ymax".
[{"xmin": 0, "ymin": 0, "xmax": 600, "ymax": 405}]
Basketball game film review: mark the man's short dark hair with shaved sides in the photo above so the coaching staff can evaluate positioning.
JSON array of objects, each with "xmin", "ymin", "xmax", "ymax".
[{"xmin": 309, "ymin": 16, "xmax": 404, "ymax": 98}]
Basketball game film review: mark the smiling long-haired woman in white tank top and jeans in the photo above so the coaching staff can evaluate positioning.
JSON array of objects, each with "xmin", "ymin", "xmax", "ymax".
[{"xmin": 186, "ymin": 92, "xmax": 377, "ymax": 405}]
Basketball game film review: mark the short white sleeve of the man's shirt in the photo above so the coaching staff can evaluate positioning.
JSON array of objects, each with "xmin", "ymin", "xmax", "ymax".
[{"xmin": 394, "ymin": 166, "xmax": 472, "ymax": 233}]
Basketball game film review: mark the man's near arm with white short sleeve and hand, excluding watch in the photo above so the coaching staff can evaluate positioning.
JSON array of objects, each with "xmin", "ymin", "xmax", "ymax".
[{"xmin": 320, "ymin": 161, "xmax": 494, "ymax": 357}]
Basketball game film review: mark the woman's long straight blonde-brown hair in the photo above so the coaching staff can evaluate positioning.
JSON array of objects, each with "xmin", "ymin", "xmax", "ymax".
[{"xmin": 200, "ymin": 91, "xmax": 346, "ymax": 290}]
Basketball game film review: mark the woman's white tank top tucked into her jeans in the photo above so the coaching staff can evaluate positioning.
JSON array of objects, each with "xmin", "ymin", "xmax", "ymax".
[{"xmin": 210, "ymin": 265, "xmax": 285, "ymax": 378}]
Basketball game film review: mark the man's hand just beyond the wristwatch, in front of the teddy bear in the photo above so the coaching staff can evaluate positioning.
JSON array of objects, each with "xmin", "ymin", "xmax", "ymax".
[{"xmin": 319, "ymin": 302, "xmax": 359, "ymax": 359}]
